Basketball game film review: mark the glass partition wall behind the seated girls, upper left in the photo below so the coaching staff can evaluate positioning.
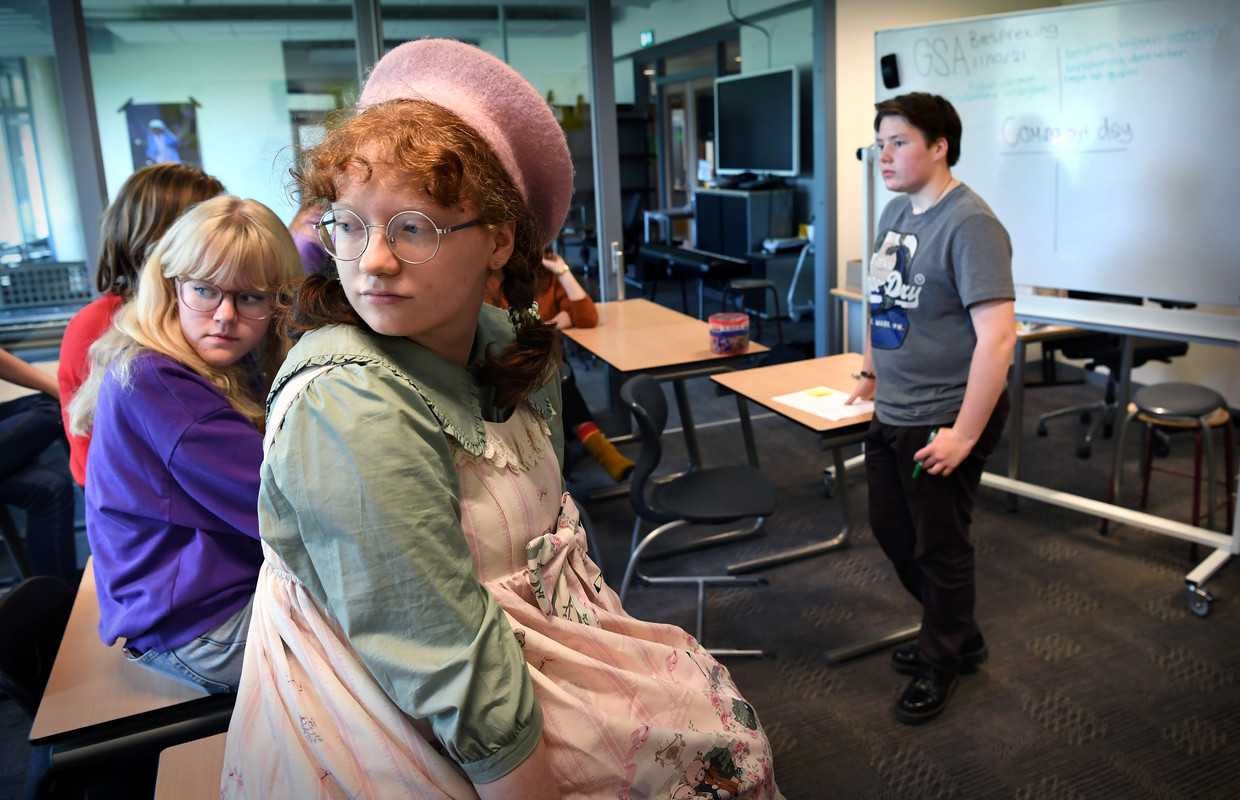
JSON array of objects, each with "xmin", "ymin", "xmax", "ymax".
[{"xmin": 0, "ymin": 0, "xmax": 591, "ymax": 249}]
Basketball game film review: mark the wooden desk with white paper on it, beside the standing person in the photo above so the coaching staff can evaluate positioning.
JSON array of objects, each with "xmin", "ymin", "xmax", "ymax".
[{"xmin": 711, "ymin": 352, "xmax": 873, "ymax": 574}]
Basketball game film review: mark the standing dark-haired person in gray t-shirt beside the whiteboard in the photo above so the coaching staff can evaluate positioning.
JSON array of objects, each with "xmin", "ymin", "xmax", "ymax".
[{"xmin": 848, "ymin": 93, "xmax": 1016, "ymax": 724}]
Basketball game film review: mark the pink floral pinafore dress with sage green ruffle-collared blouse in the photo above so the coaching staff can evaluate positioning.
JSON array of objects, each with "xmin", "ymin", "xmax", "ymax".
[{"xmin": 221, "ymin": 309, "xmax": 780, "ymax": 799}]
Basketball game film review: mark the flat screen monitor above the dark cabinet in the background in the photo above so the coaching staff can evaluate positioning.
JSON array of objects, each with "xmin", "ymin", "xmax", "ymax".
[{"xmin": 714, "ymin": 67, "xmax": 801, "ymax": 177}]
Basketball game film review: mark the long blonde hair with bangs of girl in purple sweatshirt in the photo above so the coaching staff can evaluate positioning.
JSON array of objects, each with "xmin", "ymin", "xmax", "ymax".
[{"xmin": 69, "ymin": 195, "xmax": 304, "ymax": 435}]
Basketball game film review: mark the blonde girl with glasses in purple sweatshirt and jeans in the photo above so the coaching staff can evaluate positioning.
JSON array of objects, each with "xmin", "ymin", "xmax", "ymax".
[{"xmin": 69, "ymin": 195, "xmax": 301, "ymax": 693}]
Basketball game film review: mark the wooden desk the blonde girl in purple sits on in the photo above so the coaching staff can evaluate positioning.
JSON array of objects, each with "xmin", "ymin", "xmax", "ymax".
[{"xmin": 30, "ymin": 557, "xmax": 236, "ymax": 769}]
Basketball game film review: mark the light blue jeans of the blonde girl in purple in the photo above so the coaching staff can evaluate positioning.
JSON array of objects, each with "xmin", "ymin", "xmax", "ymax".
[{"xmin": 125, "ymin": 597, "xmax": 254, "ymax": 695}]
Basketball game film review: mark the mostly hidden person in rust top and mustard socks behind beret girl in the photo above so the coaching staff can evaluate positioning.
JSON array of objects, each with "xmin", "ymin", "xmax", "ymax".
[{"xmin": 486, "ymin": 251, "xmax": 635, "ymax": 482}]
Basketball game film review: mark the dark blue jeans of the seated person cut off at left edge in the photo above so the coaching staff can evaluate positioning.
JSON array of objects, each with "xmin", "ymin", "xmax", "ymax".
[{"xmin": 0, "ymin": 394, "xmax": 78, "ymax": 584}]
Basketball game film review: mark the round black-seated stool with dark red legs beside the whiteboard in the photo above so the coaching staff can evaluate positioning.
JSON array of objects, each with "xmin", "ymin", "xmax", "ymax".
[{"xmin": 1102, "ymin": 383, "xmax": 1235, "ymax": 533}]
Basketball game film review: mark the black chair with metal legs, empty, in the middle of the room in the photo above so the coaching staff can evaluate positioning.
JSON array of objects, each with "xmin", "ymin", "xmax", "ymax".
[{"xmin": 620, "ymin": 375, "xmax": 775, "ymax": 657}]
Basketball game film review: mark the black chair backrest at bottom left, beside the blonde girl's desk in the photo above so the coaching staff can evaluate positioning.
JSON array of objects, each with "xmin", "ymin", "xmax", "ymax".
[{"xmin": 0, "ymin": 576, "xmax": 76, "ymax": 719}]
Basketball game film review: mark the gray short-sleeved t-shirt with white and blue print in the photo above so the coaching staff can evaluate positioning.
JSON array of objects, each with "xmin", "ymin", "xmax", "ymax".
[{"xmin": 868, "ymin": 184, "xmax": 1016, "ymax": 425}]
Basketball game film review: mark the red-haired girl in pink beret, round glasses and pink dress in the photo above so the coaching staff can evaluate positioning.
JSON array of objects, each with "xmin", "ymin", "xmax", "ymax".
[{"xmin": 221, "ymin": 40, "xmax": 780, "ymax": 800}]
